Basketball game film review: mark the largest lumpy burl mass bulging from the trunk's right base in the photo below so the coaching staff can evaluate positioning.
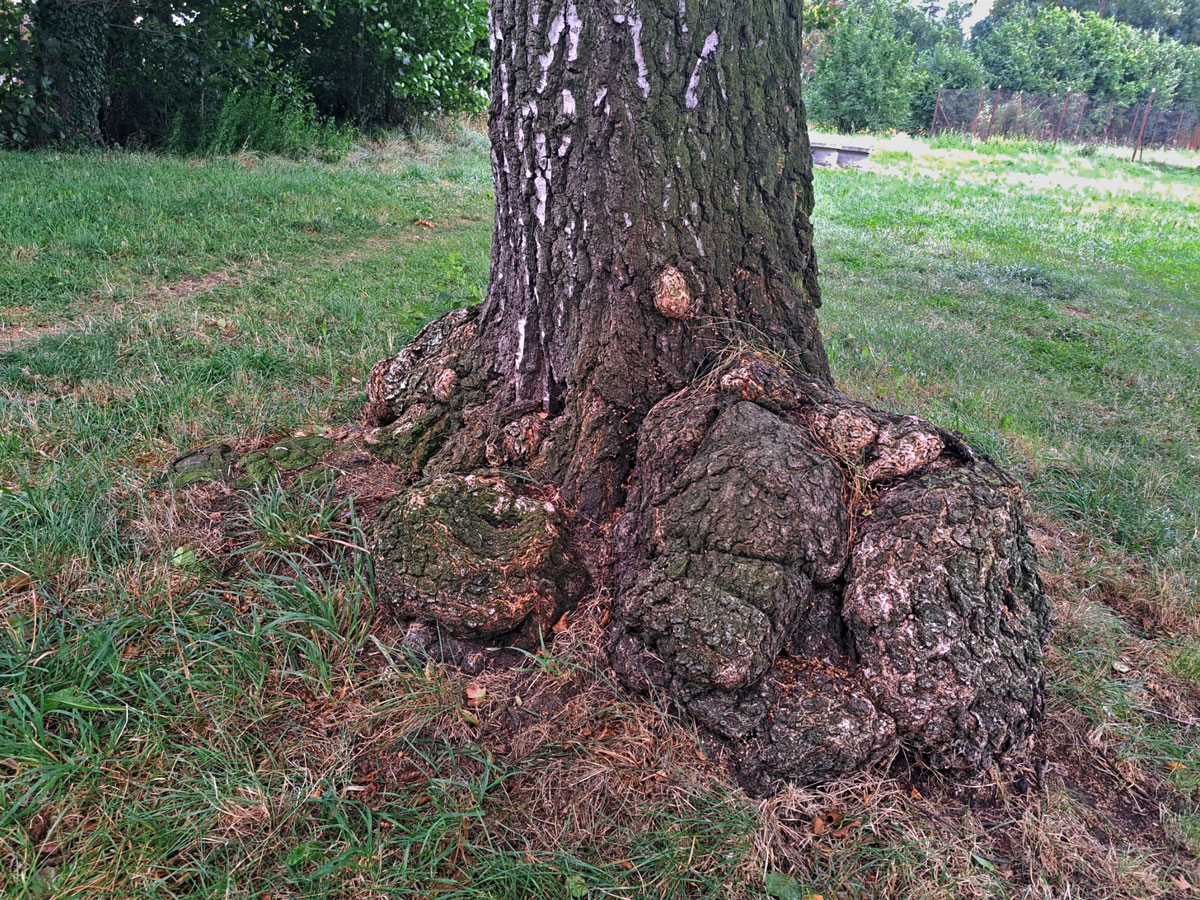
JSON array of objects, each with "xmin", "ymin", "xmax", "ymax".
[{"xmin": 611, "ymin": 355, "xmax": 1050, "ymax": 788}]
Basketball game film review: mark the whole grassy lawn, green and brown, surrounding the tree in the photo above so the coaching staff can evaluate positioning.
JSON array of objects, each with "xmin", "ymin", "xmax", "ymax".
[{"xmin": 0, "ymin": 121, "xmax": 1200, "ymax": 900}]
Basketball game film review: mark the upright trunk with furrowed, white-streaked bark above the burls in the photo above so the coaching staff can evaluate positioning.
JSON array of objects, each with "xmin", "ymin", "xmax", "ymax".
[{"xmin": 376, "ymin": 0, "xmax": 829, "ymax": 518}]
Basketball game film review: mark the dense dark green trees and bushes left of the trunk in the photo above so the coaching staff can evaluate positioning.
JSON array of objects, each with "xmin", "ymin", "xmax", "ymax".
[{"xmin": 0, "ymin": 0, "xmax": 487, "ymax": 152}]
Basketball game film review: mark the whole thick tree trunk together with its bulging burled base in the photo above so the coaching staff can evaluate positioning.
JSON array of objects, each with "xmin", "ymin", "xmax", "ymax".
[{"xmin": 367, "ymin": 0, "xmax": 1050, "ymax": 790}]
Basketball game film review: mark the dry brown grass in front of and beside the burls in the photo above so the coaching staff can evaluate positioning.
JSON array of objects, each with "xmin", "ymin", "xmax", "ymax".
[{"xmin": 114, "ymin": 465, "xmax": 1200, "ymax": 900}]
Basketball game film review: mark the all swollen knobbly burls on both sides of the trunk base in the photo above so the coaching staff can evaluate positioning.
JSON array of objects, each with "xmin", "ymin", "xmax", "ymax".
[{"xmin": 368, "ymin": 311, "xmax": 1051, "ymax": 791}]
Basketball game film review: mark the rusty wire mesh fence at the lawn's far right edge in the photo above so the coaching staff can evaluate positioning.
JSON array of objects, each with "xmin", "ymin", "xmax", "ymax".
[{"xmin": 929, "ymin": 88, "xmax": 1200, "ymax": 150}]
